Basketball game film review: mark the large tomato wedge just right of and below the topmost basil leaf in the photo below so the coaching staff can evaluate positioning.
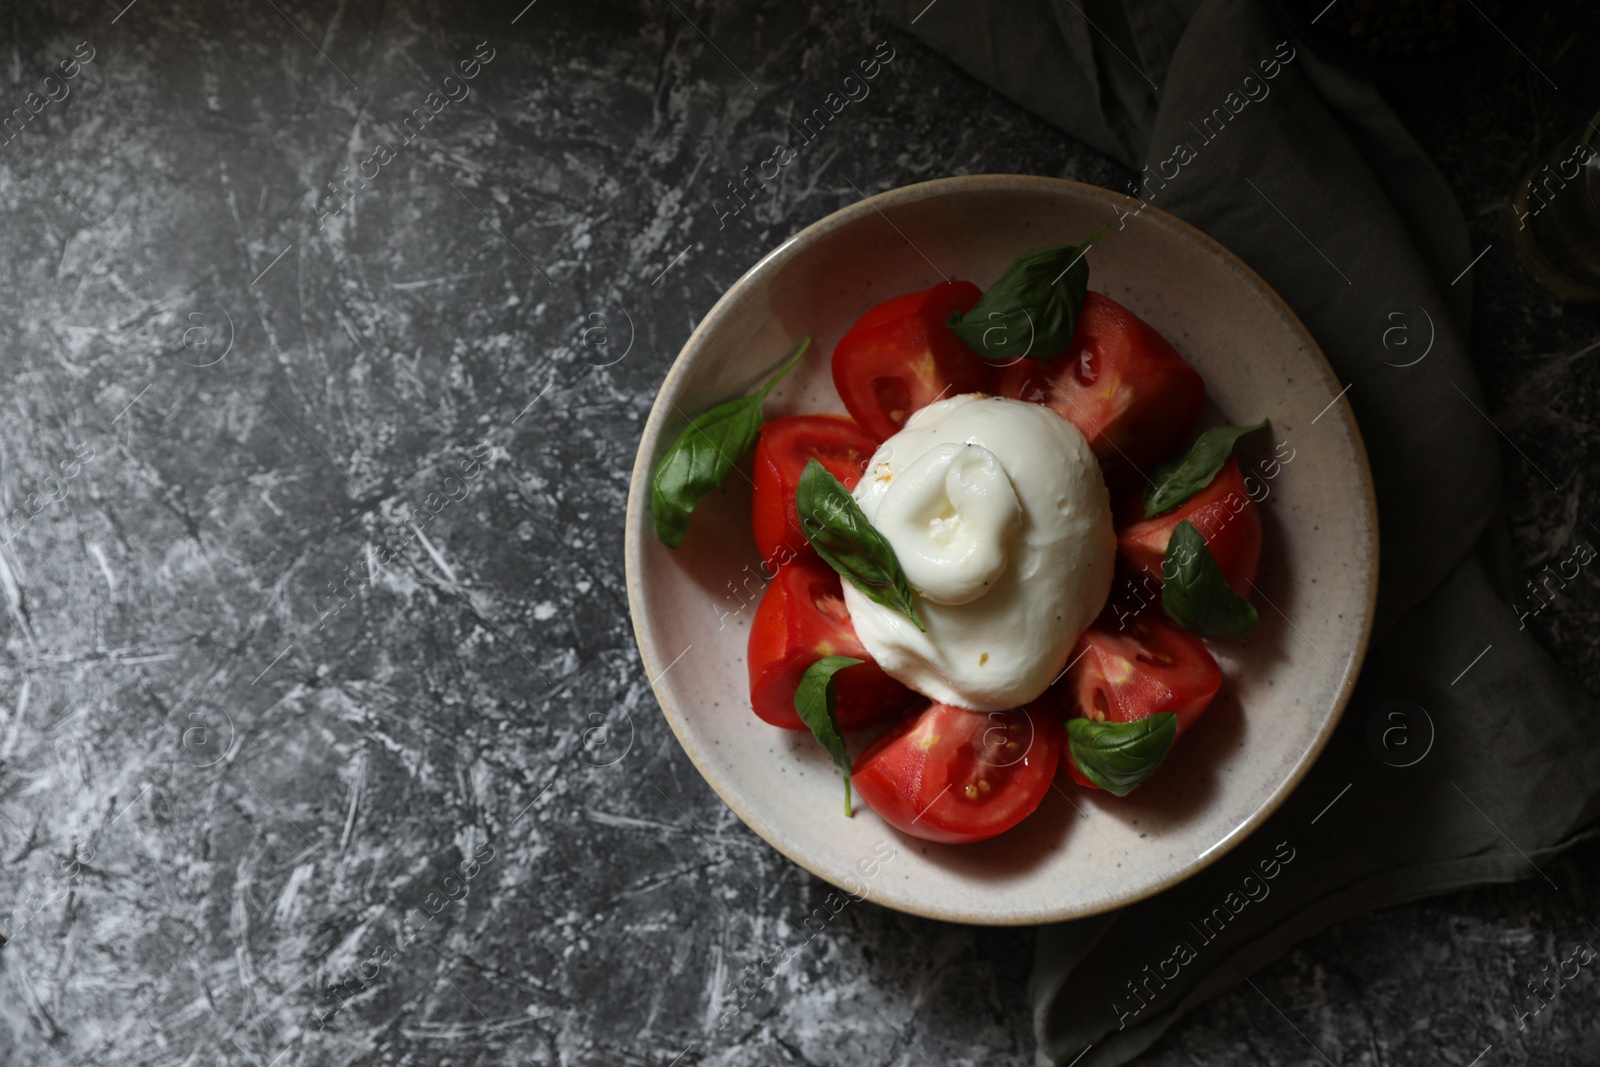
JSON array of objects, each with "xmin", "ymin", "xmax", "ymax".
[{"xmin": 995, "ymin": 293, "xmax": 1205, "ymax": 493}]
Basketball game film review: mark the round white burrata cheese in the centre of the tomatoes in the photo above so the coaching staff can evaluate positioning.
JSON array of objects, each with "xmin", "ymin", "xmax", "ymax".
[{"xmin": 845, "ymin": 394, "xmax": 1117, "ymax": 712}]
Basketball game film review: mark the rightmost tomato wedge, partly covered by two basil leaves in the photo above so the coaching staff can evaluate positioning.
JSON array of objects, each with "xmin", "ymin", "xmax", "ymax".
[{"xmin": 1117, "ymin": 456, "xmax": 1261, "ymax": 598}]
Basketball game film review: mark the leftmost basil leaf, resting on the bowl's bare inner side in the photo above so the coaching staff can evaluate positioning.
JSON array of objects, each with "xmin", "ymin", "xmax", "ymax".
[{"xmin": 650, "ymin": 338, "xmax": 811, "ymax": 549}]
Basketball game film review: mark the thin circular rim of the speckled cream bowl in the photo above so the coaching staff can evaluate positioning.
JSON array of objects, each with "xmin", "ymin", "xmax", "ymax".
[{"xmin": 622, "ymin": 174, "xmax": 1381, "ymax": 926}]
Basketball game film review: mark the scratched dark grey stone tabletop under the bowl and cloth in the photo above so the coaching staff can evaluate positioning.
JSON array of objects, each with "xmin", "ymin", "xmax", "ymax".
[{"xmin": 0, "ymin": 0, "xmax": 1600, "ymax": 1067}]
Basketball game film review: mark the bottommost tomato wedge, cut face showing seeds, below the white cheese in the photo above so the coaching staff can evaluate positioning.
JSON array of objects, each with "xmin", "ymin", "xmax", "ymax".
[{"xmin": 850, "ymin": 704, "xmax": 1061, "ymax": 845}]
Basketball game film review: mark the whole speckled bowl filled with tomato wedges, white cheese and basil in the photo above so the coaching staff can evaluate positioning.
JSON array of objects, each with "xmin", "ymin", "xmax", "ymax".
[{"xmin": 627, "ymin": 178, "xmax": 1376, "ymax": 923}]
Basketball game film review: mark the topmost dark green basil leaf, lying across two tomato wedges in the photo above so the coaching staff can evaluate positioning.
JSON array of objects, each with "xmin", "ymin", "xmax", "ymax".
[{"xmin": 946, "ymin": 226, "xmax": 1110, "ymax": 363}]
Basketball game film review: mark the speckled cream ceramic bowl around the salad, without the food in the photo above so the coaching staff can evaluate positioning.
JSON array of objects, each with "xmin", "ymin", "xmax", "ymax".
[{"xmin": 624, "ymin": 174, "xmax": 1378, "ymax": 925}]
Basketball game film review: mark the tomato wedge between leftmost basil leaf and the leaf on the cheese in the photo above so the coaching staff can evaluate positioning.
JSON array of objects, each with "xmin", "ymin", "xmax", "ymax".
[{"xmin": 750, "ymin": 414, "xmax": 877, "ymax": 569}]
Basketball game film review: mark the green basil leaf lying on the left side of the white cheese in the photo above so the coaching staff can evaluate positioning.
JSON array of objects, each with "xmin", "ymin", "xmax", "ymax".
[{"xmin": 795, "ymin": 459, "xmax": 928, "ymax": 630}]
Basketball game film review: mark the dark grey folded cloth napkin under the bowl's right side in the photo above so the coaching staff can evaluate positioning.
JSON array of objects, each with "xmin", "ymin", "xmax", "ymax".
[{"xmin": 883, "ymin": 0, "xmax": 1600, "ymax": 1067}]
